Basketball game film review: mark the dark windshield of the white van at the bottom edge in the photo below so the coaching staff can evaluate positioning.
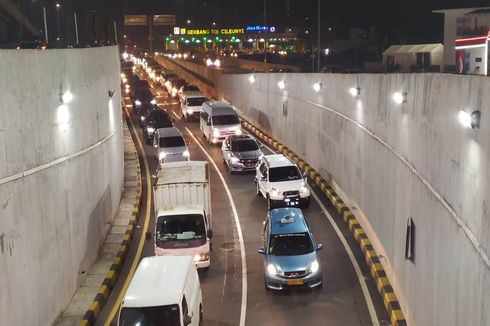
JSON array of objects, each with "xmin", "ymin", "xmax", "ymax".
[{"xmin": 118, "ymin": 304, "xmax": 180, "ymax": 326}]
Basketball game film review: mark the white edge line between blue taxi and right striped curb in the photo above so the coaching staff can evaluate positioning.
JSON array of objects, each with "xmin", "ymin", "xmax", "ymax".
[{"xmin": 260, "ymin": 142, "xmax": 379, "ymax": 326}]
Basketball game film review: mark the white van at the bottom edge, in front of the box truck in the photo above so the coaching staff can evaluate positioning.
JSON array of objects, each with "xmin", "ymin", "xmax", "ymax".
[{"xmin": 117, "ymin": 256, "xmax": 203, "ymax": 326}]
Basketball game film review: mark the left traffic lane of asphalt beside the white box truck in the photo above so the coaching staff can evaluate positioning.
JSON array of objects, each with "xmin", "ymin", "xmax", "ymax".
[{"xmin": 145, "ymin": 90, "xmax": 241, "ymax": 326}]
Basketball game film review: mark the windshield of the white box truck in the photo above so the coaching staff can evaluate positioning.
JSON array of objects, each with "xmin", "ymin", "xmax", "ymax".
[{"xmin": 156, "ymin": 214, "xmax": 206, "ymax": 242}]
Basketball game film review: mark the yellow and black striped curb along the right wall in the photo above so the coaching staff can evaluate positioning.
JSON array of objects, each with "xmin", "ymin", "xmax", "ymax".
[{"xmin": 241, "ymin": 117, "xmax": 407, "ymax": 326}]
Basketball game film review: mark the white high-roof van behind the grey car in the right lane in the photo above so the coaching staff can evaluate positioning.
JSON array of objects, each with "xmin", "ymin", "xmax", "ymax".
[{"xmin": 199, "ymin": 101, "xmax": 242, "ymax": 144}]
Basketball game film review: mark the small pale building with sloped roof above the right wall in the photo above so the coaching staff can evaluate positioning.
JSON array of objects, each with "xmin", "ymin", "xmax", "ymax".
[{"xmin": 383, "ymin": 43, "xmax": 444, "ymax": 72}]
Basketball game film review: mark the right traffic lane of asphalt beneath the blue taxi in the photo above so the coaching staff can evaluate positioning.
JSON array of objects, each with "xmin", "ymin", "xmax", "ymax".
[{"xmin": 173, "ymin": 110, "xmax": 380, "ymax": 325}]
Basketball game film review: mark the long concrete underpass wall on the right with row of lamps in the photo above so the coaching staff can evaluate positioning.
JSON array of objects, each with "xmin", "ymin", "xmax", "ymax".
[{"xmin": 216, "ymin": 73, "xmax": 490, "ymax": 325}]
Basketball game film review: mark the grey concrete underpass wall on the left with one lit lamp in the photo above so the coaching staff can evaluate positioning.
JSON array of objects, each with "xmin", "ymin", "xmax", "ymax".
[{"xmin": 0, "ymin": 46, "xmax": 124, "ymax": 325}]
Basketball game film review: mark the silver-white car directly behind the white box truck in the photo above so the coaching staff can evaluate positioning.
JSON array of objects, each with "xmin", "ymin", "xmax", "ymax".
[{"xmin": 153, "ymin": 127, "xmax": 190, "ymax": 163}]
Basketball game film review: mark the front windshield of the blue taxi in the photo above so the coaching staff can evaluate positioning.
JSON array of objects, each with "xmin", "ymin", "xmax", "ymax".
[{"xmin": 269, "ymin": 232, "xmax": 313, "ymax": 256}]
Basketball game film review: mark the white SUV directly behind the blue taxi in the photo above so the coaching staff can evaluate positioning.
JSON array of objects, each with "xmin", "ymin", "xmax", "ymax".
[{"xmin": 255, "ymin": 154, "xmax": 310, "ymax": 209}]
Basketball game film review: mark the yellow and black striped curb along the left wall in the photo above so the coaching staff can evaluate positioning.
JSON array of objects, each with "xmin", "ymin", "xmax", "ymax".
[{"xmin": 80, "ymin": 105, "xmax": 142, "ymax": 326}]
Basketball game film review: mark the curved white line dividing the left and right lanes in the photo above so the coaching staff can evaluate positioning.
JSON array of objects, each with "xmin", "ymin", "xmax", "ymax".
[{"xmin": 185, "ymin": 127, "xmax": 247, "ymax": 326}]
